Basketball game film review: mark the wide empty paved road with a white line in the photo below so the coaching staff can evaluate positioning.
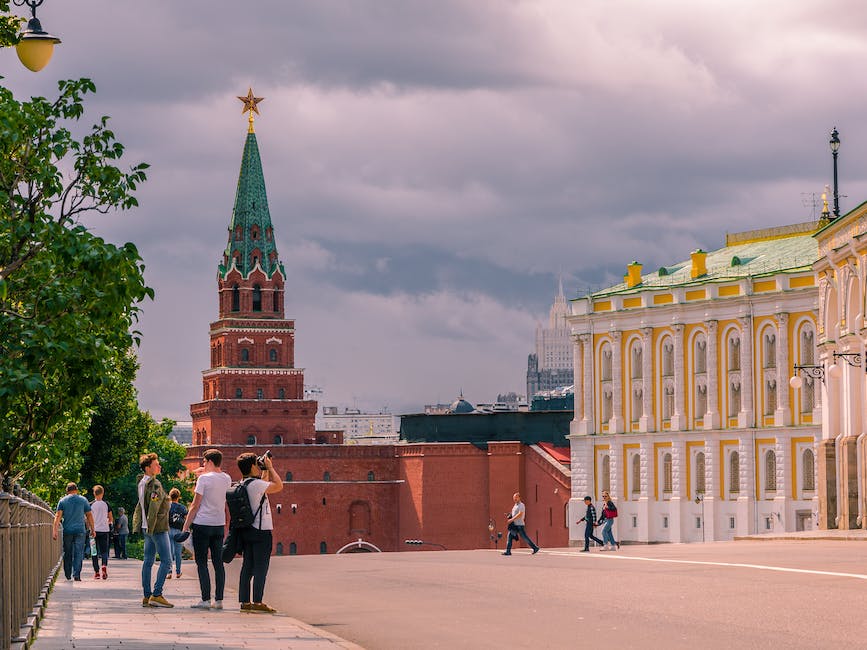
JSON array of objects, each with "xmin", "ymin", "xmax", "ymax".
[{"xmin": 249, "ymin": 541, "xmax": 867, "ymax": 650}]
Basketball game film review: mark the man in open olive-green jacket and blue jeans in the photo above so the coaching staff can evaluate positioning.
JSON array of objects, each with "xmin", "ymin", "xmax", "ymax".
[{"xmin": 132, "ymin": 454, "xmax": 174, "ymax": 607}]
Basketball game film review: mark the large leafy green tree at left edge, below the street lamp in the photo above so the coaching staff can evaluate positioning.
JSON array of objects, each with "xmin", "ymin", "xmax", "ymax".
[{"xmin": 0, "ymin": 78, "xmax": 153, "ymax": 484}]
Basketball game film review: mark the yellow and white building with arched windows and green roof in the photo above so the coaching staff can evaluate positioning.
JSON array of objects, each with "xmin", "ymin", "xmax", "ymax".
[{"xmin": 567, "ymin": 222, "xmax": 820, "ymax": 543}]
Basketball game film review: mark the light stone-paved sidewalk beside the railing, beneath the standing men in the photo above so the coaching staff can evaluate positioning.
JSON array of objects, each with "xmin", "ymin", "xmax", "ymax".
[{"xmin": 31, "ymin": 560, "xmax": 361, "ymax": 650}]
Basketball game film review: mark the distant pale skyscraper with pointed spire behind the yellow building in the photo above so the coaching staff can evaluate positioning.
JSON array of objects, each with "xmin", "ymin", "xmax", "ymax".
[{"xmin": 527, "ymin": 278, "xmax": 573, "ymax": 394}]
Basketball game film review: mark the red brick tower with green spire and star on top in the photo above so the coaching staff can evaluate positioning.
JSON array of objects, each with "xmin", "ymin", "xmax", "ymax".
[{"xmin": 190, "ymin": 90, "xmax": 317, "ymax": 446}]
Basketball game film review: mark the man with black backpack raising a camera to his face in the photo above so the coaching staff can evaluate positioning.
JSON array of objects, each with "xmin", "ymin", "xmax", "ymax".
[{"xmin": 238, "ymin": 452, "xmax": 283, "ymax": 613}]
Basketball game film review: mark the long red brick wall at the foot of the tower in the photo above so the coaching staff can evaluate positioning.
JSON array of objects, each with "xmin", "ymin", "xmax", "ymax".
[{"xmin": 185, "ymin": 443, "xmax": 569, "ymax": 555}]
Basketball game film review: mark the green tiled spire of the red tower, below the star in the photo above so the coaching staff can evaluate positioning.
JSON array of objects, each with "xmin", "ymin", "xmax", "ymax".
[{"xmin": 220, "ymin": 129, "xmax": 285, "ymax": 278}]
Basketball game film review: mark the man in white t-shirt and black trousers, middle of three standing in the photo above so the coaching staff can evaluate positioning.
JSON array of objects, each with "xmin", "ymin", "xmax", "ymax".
[{"xmin": 183, "ymin": 449, "xmax": 232, "ymax": 609}]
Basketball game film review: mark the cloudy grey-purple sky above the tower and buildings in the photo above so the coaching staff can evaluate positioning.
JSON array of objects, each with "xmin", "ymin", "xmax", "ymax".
[{"xmin": 0, "ymin": 0, "xmax": 867, "ymax": 419}]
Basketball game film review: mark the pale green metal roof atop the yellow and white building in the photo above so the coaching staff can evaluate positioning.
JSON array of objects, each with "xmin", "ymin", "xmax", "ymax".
[{"xmin": 591, "ymin": 224, "xmax": 819, "ymax": 298}]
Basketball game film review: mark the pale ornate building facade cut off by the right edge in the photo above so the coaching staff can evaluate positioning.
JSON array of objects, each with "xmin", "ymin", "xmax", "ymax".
[{"xmin": 816, "ymin": 203, "xmax": 867, "ymax": 530}]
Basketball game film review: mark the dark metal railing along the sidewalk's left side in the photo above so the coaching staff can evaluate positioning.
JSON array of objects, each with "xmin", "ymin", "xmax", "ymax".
[{"xmin": 0, "ymin": 476, "xmax": 63, "ymax": 650}]
